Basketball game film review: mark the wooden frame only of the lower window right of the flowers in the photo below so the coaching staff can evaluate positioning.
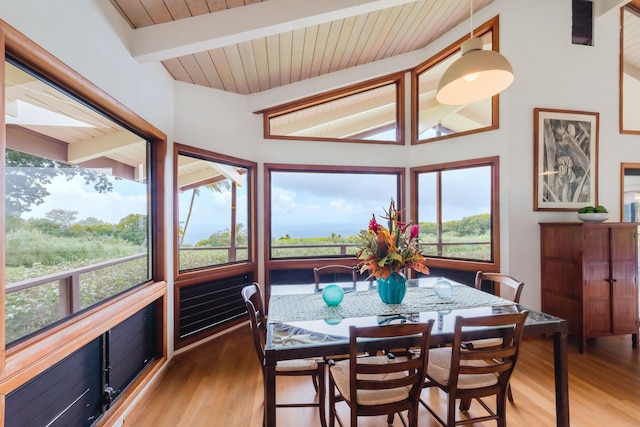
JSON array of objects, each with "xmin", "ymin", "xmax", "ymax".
[{"xmin": 410, "ymin": 156, "xmax": 500, "ymax": 272}]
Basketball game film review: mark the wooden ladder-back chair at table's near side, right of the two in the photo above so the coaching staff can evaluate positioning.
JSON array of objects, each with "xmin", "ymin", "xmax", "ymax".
[{"xmin": 420, "ymin": 311, "xmax": 528, "ymax": 427}]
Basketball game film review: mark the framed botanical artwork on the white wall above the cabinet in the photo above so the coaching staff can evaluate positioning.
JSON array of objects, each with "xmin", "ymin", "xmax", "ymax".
[{"xmin": 533, "ymin": 108, "xmax": 600, "ymax": 211}]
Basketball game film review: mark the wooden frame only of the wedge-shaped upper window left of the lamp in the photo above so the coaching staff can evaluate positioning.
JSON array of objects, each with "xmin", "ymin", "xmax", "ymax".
[{"xmin": 255, "ymin": 71, "xmax": 405, "ymax": 145}]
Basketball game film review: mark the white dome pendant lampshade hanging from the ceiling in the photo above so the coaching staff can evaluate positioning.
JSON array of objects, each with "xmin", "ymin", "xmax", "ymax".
[{"xmin": 436, "ymin": 37, "xmax": 513, "ymax": 105}]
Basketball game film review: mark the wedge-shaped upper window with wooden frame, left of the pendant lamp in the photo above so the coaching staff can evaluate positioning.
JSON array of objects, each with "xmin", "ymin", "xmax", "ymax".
[{"xmin": 259, "ymin": 74, "xmax": 404, "ymax": 144}]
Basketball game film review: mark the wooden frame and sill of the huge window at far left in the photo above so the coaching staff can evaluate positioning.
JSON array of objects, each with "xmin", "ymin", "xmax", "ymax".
[{"xmin": 0, "ymin": 20, "xmax": 167, "ymax": 417}]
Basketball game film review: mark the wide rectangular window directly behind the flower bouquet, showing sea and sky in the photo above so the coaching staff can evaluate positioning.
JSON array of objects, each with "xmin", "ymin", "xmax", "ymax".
[{"xmin": 265, "ymin": 165, "xmax": 404, "ymax": 259}]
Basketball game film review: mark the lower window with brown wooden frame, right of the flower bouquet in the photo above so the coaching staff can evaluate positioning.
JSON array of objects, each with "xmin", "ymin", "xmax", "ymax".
[{"xmin": 411, "ymin": 157, "xmax": 500, "ymax": 270}]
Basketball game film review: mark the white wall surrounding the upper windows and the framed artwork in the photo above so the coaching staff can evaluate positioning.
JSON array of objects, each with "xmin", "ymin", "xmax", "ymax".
[{"xmin": 176, "ymin": 0, "xmax": 640, "ymax": 308}]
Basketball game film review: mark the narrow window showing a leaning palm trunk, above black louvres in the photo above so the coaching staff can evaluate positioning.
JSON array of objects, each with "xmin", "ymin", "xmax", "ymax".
[{"xmin": 174, "ymin": 144, "xmax": 255, "ymax": 272}]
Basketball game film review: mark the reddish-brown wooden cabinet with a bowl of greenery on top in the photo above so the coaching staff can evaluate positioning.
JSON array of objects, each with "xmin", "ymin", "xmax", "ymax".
[{"xmin": 540, "ymin": 222, "xmax": 639, "ymax": 352}]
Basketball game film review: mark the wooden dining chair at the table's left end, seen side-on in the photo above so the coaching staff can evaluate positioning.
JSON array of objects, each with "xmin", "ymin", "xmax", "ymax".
[{"xmin": 242, "ymin": 283, "xmax": 327, "ymax": 427}]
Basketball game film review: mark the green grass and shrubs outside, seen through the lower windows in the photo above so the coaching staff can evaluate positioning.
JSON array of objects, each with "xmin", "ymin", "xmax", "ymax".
[{"xmin": 5, "ymin": 230, "xmax": 490, "ymax": 343}]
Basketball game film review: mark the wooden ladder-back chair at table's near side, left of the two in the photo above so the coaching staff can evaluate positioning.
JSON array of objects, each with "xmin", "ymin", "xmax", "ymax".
[{"xmin": 329, "ymin": 320, "xmax": 433, "ymax": 427}]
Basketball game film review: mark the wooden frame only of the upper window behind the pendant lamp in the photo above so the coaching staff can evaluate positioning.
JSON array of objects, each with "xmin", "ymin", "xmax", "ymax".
[{"xmin": 411, "ymin": 16, "xmax": 500, "ymax": 145}]
